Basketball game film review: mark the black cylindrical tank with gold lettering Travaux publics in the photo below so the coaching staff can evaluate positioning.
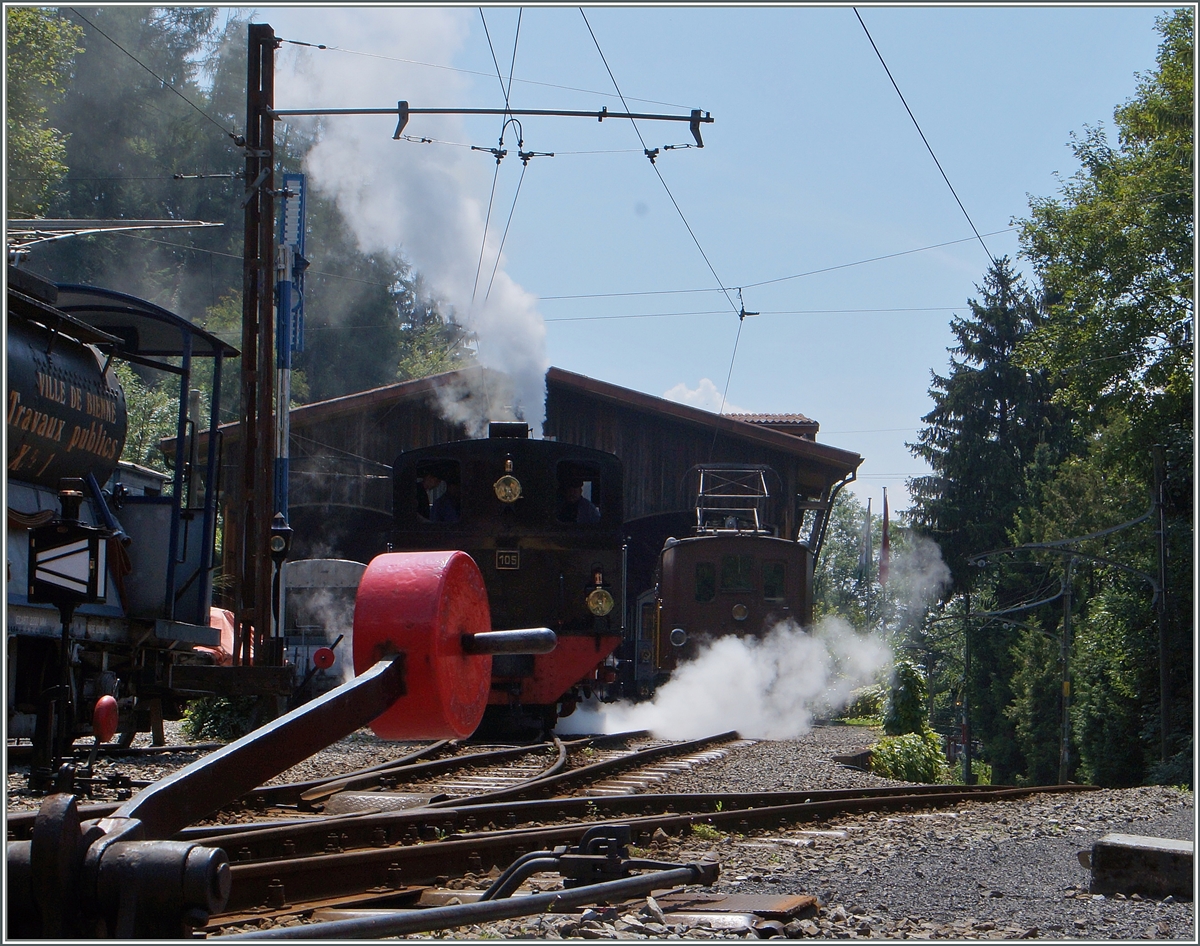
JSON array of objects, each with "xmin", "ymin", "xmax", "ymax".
[{"xmin": 5, "ymin": 319, "xmax": 127, "ymax": 487}]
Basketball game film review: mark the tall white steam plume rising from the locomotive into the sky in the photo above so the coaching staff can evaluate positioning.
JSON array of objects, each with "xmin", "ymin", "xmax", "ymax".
[{"xmin": 276, "ymin": 7, "xmax": 548, "ymax": 436}]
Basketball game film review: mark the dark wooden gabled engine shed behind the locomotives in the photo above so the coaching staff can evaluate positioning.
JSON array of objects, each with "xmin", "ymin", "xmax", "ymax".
[{"xmin": 208, "ymin": 367, "xmax": 862, "ymax": 588}]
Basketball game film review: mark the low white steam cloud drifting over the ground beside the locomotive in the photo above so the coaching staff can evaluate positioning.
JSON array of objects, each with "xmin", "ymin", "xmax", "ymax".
[{"xmin": 557, "ymin": 618, "xmax": 892, "ymax": 740}]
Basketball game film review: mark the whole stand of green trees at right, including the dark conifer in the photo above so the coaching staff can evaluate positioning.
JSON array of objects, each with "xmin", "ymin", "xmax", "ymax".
[{"xmin": 911, "ymin": 7, "xmax": 1195, "ymax": 786}]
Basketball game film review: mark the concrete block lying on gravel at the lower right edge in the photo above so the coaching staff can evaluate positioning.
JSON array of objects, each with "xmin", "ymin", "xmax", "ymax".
[{"xmin": 1079, "ymin": 834, "xmax": 1193, "ymax": 900}]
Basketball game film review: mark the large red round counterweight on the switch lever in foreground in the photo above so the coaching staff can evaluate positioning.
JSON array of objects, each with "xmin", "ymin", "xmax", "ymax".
[{"xmin": 354, "ymin": 552, "xmax": 492, "ymax": 740}]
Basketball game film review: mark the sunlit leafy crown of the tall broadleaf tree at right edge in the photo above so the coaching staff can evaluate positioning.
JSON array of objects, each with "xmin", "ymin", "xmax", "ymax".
[{"xmin": 1021, "ymin": 8, "xmax": 1195, "ymax": 437}]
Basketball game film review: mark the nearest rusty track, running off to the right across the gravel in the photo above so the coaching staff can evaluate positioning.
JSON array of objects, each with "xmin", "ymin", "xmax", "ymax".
[{"xmin": 194, "ymin": 785, "xmax": 1099, "ymax": 933}]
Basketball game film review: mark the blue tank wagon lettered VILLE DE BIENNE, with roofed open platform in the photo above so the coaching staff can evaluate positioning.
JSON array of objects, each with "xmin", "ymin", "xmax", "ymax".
[{"xmin": 6, "ymin": 267, "xmax": 290, "ymax": 788}]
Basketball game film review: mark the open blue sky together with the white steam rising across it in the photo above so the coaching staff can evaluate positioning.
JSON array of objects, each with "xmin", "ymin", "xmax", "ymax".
[{"xmin": 254, "ymin": 5, "xmax": 1165, "ymax": 509}]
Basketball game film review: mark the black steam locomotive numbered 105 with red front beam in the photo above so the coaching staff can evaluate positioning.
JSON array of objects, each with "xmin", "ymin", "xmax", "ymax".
[{"xmin": 386, "ymin": 423, "xmax": 625, "ymax": 735}]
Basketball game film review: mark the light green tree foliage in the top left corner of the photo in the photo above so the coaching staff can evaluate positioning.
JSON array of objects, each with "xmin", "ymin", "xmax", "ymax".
[{"xmin": 5, "ymin": 7, "xmax": 83, "ymax": 218}]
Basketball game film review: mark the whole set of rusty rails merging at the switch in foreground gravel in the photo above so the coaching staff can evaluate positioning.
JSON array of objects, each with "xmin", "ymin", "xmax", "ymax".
[{"xmin": 8, "ymin": 734, "xmax": 1099, "ymax": 936}]
